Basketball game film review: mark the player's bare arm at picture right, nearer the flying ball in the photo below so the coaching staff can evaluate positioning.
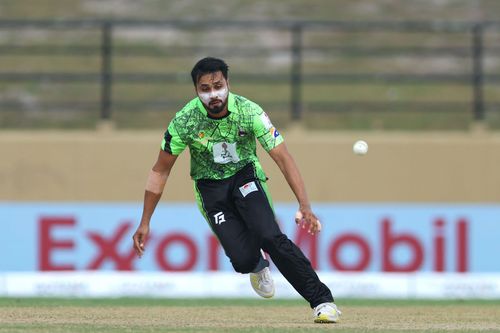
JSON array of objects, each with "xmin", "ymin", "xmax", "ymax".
[{"xmin": 269, "ymin": 142, "xmax": 321, "ymax": 234}]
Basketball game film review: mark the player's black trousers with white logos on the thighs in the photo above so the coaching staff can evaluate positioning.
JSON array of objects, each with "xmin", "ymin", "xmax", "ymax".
[{"xmin": 195, "ymin": 164, "xmax": 333, "ymax": 307}]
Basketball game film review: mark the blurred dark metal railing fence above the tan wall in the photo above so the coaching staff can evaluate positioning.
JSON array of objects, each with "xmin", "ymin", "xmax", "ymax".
[{"xmin": 0, "ymin": 20, "xmax": 500, "ymax": 128}]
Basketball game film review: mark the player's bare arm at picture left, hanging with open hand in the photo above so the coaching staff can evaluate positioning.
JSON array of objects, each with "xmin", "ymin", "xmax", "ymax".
[{"xmin": 132, "ymin": 150, "xmax": 177, "ymax": 257}]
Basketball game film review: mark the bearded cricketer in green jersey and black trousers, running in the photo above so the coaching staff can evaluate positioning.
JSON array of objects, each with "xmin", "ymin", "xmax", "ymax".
[{"xmin": 133, "ymin": 58, "xmax": 341, "ymax": 323}]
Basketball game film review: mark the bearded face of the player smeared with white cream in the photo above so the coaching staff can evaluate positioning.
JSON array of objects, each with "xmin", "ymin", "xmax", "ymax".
[{"xmin": 196, "ymin": 72, "xmax": 229, "ymax": 115}]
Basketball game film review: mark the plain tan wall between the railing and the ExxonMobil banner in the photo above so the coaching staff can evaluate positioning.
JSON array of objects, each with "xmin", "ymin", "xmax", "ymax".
[{"xmin": 0, "ymin": 129, "xmax": 500, "ymax": 203}]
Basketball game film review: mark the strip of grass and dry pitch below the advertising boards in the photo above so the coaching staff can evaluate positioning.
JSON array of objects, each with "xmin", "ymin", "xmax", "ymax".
[{"xmin": 0, "ymin": 298, "xmax": 500, "ymax": 333}]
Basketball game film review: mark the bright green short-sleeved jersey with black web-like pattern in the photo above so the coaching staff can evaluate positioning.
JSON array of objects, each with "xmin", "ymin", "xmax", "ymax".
[{"xmin": 161, "ymin": 93, "xmax": 283, "ymax": 180}]
